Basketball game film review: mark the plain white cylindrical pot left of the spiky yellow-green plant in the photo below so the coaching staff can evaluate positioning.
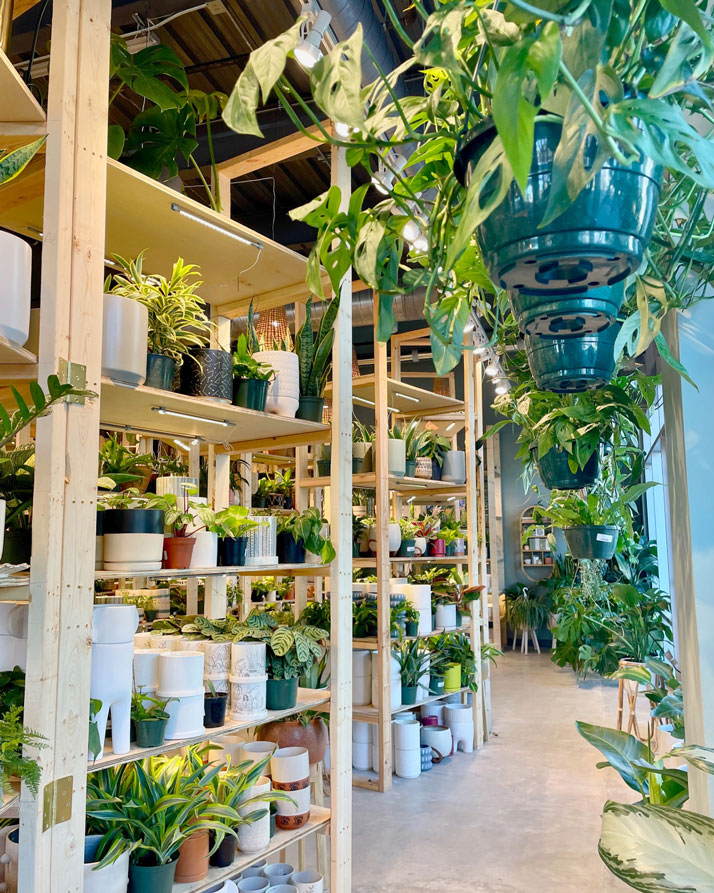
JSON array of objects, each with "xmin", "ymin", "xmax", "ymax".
[{"xmin": 102, "ymin": 294, "xmax": 149, "ymax": 388}]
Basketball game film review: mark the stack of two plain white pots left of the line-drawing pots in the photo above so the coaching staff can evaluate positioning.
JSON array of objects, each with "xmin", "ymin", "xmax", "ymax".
[{"xmin": 156, "ymin": 651, "xmax": 204, "ymax": 741}]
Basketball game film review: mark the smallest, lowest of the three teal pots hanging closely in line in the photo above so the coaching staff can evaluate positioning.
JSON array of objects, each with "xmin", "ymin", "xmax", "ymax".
[{"xmin": 525, "ymin": 323, "xmax": 620, "ymax": 394}]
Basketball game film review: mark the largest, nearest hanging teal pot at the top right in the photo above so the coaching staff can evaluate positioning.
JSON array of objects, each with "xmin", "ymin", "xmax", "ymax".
[{"xmin": 454, "ymin": 119, "xmax": 662, "ymax": 292}]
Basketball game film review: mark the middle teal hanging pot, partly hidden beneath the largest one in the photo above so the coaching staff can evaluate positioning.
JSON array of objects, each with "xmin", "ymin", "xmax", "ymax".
[{"xmin": 509, "ymin": 282, "xmax": 625, "ymax": 338}]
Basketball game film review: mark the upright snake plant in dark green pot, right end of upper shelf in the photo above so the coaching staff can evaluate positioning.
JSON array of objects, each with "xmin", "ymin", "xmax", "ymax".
[{"xmin": 295, "ymin": 293, "xmax": 340, "ymax": 422}]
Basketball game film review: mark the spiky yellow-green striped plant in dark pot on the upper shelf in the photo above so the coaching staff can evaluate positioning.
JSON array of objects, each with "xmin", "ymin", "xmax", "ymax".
[{"xmin": 104, "ymin": 251, "xmax": 211, "ymax": 391}]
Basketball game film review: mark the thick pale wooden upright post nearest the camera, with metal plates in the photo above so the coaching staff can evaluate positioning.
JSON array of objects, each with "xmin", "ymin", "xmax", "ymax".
[{"xmin": 18, "ymin": 0, "xmax": 111, "ymax": 893}]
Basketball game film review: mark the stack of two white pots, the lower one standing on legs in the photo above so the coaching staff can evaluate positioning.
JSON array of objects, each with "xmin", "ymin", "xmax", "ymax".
[{"xmin": 89, "ymin": 605, "xmax": 139, "ymax": 757}]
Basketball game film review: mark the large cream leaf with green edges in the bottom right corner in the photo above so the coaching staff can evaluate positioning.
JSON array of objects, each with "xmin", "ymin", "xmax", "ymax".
[{"xmin": 598, "ymin": 801, "xmax": 714, "ymax": 893}]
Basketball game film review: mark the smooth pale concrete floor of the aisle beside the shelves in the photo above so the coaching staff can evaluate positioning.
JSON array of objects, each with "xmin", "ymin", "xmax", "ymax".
[{"xmin": 354, "ymin": 651, "xmax": 632, "ymax": 893}]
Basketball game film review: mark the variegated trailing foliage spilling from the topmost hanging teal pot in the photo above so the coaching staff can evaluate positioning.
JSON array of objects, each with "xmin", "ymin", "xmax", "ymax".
[{"xmin": 223, "ymin": 0, "xmax": 714, "ymax": 372}]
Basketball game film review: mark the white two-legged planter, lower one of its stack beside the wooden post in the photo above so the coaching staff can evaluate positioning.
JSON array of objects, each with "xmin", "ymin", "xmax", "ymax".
[{"xmin": 89, "ymin": 636, "xmax": 134, "ymax": 757}]
